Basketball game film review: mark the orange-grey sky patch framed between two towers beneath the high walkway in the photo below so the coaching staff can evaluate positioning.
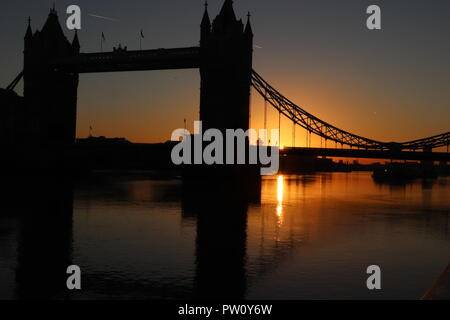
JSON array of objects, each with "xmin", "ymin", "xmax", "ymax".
[{"xmin": 77, "ymin": 70, "xmax": 200, "ymax": 143}]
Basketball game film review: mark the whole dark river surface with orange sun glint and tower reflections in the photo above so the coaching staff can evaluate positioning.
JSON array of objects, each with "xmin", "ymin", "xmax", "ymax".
[{"xmin": 0, "ymin": 173, "xmax": 450, "ymax": 299}]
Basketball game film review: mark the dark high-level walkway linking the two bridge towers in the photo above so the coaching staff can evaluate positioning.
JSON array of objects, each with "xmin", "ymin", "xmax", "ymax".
[{"xmin": 54, "ymin": 47, "xmax": 200, "ymax": 73}]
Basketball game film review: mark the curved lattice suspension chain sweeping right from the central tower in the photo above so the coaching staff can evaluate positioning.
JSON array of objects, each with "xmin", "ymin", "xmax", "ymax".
[{"xmin": 252, "ymin": 70, "xmax": 450, "ymax": 151}]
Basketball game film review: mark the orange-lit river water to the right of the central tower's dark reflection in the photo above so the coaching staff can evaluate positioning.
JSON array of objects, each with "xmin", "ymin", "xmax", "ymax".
[{"xmin": 247, "ymin": 173, "xmax": 450, "ymax": 299}]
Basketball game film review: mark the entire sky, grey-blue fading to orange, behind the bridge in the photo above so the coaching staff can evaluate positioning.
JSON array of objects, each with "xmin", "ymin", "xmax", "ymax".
[{"xmin": 0, "ymin": 0, "xmax": 450, "ymax": 146}]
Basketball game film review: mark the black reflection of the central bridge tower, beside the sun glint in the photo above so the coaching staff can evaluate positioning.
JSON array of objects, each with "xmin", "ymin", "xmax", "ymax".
[{"xmin": 183, "ymin": 181, "xmax": 259, "ymax": 300}]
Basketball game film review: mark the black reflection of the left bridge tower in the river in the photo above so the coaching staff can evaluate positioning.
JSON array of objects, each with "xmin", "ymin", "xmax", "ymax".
[{"xmin": 3, "ymin": 178, "xmax": 73, "ymax": 299}]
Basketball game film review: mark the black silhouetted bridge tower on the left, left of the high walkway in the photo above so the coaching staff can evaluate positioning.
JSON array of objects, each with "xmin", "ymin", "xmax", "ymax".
[{"xmin": 24, "ymin": 8, "xmax": 80, "ymax": 145}]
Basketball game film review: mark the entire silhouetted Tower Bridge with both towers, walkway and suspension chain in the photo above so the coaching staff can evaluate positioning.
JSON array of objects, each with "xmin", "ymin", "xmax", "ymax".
[{"xmin": 0, "ymin": 0, "xmax": 450, "ymax": 161}]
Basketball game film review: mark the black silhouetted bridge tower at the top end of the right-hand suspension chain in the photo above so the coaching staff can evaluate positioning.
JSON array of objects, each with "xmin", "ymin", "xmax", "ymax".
[{"xmin": 200, "ymin": 0, "xmax": 253, "ymax": 131}]
